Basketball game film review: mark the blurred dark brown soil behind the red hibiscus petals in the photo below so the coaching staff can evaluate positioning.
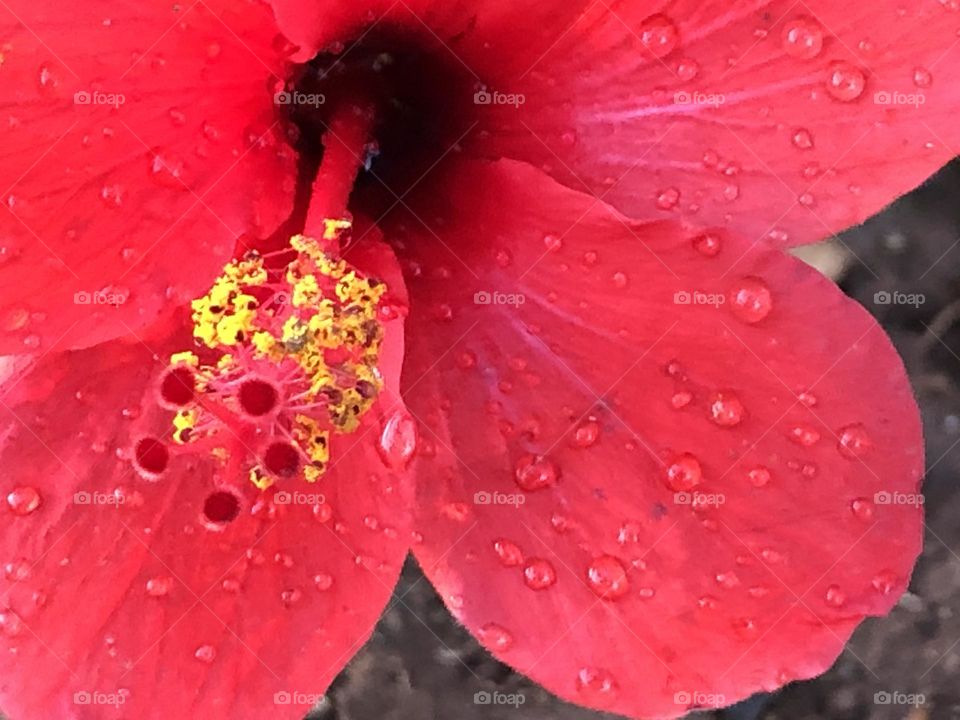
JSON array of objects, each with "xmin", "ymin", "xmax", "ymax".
[{"xmin": 310, "ymin": 161, "xmax": 960, "ymax": 720}]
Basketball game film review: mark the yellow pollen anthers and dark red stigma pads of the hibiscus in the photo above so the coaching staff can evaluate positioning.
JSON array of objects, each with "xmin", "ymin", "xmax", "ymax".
[{"xmin": 142, "ymin": 220, "xmax": 386, "ymax": 490}]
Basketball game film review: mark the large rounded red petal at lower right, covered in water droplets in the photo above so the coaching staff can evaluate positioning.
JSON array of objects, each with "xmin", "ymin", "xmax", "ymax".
[{"xmin": 388, "ymin": 161, "xmax": 923, "ymax": 717}]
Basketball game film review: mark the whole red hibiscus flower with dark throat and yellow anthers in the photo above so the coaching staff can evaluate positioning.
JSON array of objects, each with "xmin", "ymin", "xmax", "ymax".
[{"xmin": 0, "ymin": 0, "xmax": 944, "ymax": 718}]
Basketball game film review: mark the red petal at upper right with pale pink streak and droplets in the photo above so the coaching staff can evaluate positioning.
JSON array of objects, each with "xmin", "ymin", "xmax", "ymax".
[{"xmin": 472, "ymin": 0, "xmax": 960, "ymax": 245}]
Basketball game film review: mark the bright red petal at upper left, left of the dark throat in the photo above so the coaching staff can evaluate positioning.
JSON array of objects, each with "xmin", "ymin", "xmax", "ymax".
[{"xmin": 0, "ymin": 0, "xmax": 295, "ymax": 353}]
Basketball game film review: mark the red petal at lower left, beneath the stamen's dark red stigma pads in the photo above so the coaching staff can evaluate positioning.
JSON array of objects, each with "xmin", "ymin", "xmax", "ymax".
[{"xmin": 0, "ymin": 302, "xmax": 412, "ymax": 718}]
